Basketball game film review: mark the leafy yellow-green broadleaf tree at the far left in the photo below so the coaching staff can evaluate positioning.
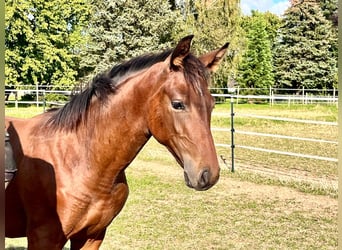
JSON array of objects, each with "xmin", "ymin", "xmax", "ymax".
[{"xmin": 5, "ymin": 0, "xmax": 89, "ymax": 87}]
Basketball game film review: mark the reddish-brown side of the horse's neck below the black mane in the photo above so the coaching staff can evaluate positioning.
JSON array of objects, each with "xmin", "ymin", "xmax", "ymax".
[{"xmin": 85, "ymin": 69, "xmax": 153, "ymax": 173}]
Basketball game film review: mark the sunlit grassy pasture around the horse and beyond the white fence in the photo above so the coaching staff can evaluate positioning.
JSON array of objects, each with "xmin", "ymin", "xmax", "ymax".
[{"xmin": 5, "ymin": 104, "xmax": 338, "ymax": 250}]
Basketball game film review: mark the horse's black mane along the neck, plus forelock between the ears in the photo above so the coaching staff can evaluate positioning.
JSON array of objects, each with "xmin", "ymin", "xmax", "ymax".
[{"xmin": 45, "ymin": 50, "xmax": 209, "ymax": 131}]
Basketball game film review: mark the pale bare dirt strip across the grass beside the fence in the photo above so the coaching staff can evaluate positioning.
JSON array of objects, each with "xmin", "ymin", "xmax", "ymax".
[{"xmin": 128, "ymin": 160, "xmax": 338, "ymax": 214}]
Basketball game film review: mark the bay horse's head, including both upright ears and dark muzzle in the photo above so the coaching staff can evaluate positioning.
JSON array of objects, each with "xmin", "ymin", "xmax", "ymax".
[{"xmin": 148, "ymin": 36, "xmax": 228, "ymax": 190}]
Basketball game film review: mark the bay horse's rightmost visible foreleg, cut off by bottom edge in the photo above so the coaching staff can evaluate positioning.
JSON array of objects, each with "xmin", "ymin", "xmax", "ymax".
[{"xmin": 70, "ymin": 229, "xmax": 106, "ymax": 250}]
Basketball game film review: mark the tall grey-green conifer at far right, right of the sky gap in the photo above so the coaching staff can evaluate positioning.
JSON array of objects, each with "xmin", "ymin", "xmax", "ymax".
[{"xmin": 274, "ymin": 0, "xmax": 337, "ymax": 89}]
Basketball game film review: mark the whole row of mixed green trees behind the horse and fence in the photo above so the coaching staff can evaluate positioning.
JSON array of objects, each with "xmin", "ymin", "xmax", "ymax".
[{"xmin": 5, "ymin": 0, "xmax": 338, "ymax": 93}]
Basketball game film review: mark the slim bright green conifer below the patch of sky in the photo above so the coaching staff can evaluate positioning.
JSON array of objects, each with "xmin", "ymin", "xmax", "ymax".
[{"xmin": 238, "ymin": 11, "xmax": 276, "ymax": 94}]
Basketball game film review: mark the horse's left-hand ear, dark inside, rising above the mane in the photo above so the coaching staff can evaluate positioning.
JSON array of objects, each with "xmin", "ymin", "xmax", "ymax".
[{"xmin": 170, "ymin": 35, "xmax": 194, "ymax": 69}]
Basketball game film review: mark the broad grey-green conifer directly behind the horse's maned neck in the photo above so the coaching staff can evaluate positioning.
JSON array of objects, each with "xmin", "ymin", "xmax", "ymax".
[{"xmin": 81, "ymin": 0, "xmax": 180, "ymax": 82}]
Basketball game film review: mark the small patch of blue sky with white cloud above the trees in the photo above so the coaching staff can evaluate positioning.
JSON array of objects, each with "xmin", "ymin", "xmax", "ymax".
[{"xmin": 240, "ymin": 0, "xmax": 290, "ymax": 16}]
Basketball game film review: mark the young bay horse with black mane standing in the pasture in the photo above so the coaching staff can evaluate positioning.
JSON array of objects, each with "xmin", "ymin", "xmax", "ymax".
[{"xmin": 5, "ymin": 36, "xmax": 228, "ymax": 250}]
